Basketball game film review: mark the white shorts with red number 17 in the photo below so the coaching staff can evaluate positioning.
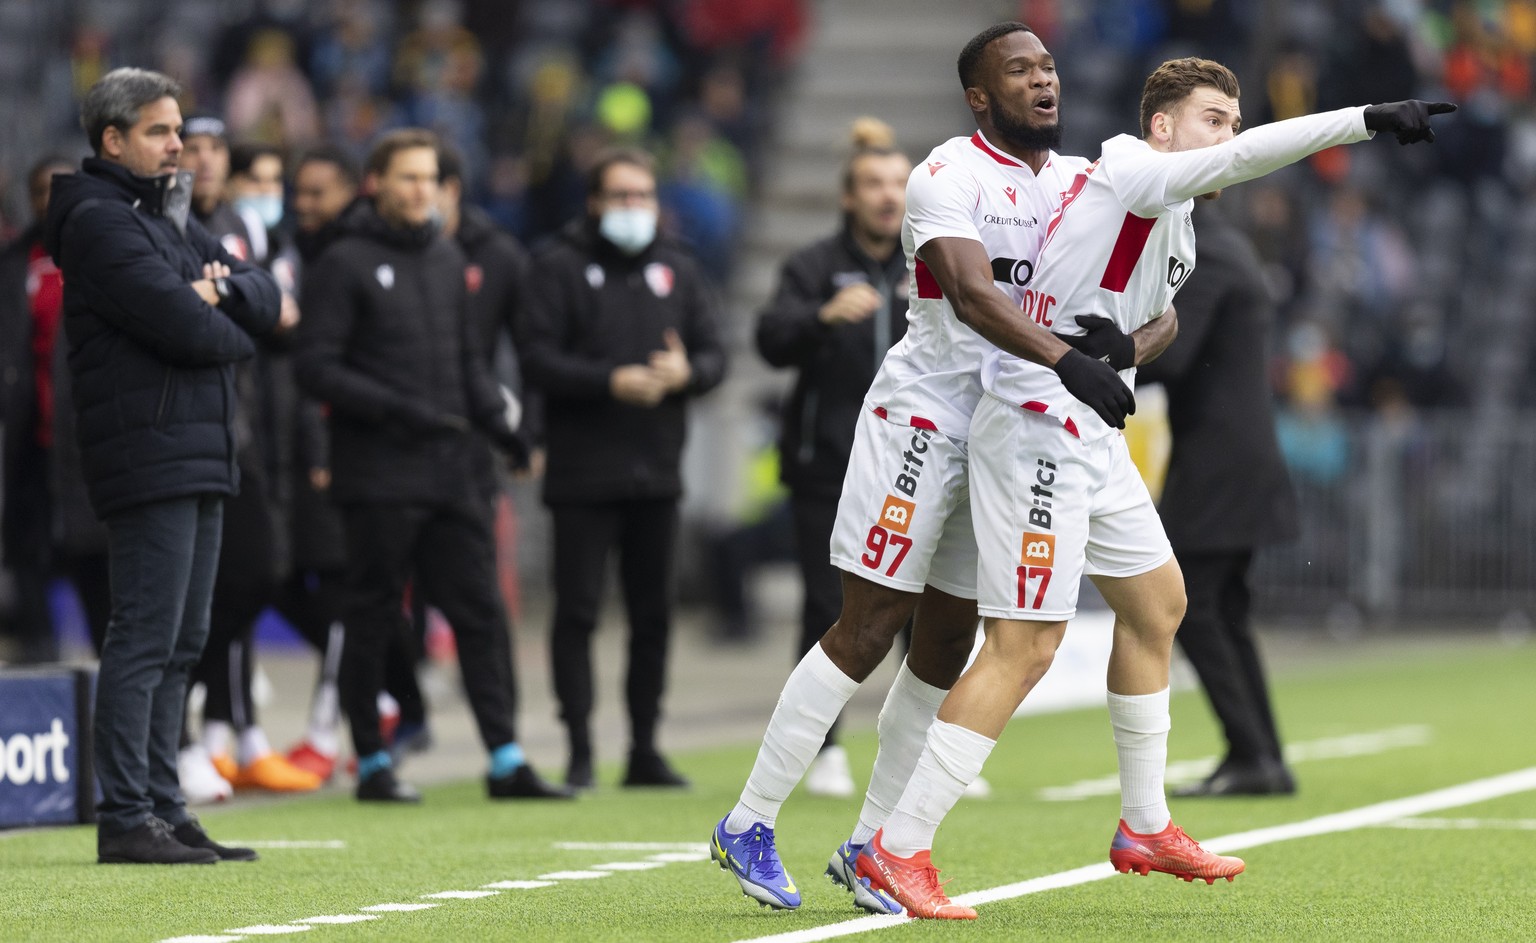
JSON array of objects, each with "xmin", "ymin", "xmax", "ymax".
[{"xmin": 971, "ymin": 395, "xmax": 1174, "ymax": 622}]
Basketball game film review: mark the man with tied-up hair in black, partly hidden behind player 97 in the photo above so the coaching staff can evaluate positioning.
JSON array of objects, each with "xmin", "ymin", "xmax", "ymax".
[{"xmin": 757, "ymin": 118, "xmax": 912, "ymax": 796}]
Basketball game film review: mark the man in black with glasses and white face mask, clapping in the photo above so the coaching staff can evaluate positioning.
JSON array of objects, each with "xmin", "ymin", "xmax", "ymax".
[{"xmin": 521, "ymin": 151, "xmax": 725, "ymax": 788}]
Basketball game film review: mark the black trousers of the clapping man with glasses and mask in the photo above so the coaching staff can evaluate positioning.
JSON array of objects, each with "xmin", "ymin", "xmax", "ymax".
[{"xmin": 550, "ymin": 498, "xmax": 677, "ymax": 753}]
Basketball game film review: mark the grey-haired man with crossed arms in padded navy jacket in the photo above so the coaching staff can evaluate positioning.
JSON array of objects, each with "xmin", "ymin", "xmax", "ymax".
[{"xmin": 43, "ymin": 69, "xmax": 278, "ymax": 863}]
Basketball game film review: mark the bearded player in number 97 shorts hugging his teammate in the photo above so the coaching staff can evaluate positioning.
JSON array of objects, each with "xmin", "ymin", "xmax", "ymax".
[{"xmin": 711, "ymin": 23, "xmax": 1172, "ymax": 912}]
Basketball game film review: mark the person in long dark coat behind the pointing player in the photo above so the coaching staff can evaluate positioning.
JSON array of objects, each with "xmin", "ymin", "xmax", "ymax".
[{"xmin": 1137, "ymin": 201, "xmax": 1296, "ymax": 796}]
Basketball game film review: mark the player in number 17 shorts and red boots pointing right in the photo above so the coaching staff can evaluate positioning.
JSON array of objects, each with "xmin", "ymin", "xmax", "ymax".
[{"xmin": 856, "ymin": 58, "xmax": 1455, "ymax": 918}]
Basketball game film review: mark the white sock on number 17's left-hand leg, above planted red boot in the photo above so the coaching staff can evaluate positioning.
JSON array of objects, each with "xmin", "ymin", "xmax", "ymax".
[{"xmin": 880, "ymin": 719, "xmax": 997, "ymax": 859}]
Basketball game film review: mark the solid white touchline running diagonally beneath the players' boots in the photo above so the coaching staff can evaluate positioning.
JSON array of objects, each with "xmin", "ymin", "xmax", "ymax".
[{"xmin": 739, "ymin": 766, "xmax": 1536, "ymax": 943}]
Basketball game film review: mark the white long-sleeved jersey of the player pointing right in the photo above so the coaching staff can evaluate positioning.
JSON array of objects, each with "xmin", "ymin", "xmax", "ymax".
[{"xmin": 982, "ymin": 108, "xmax": 1372, "ymax": 441}]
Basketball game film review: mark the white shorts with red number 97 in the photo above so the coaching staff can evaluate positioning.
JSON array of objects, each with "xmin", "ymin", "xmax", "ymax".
[{"xmin": 833, "ymin": 409, "xmax": 975, "ymax": 599}]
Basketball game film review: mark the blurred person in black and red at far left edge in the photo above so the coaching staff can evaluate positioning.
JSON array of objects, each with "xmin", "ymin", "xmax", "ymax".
[{"xmin": 0, "ymin": 155, "xmax": 111, "ymax": 665}]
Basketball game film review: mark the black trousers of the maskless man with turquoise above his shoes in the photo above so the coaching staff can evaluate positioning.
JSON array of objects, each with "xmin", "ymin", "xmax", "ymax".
[{"xmin": 341, "ymin": 499, "xmax": 518, "ymax": 756}]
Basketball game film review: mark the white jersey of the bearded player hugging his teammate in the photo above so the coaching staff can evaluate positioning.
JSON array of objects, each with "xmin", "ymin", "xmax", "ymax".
[{"xmin": 865, "ymin": 132, "xmax": 1087, "ymax": 439}]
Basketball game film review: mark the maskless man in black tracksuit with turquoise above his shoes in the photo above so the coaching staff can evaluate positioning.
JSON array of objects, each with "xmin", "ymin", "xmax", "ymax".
[{"xmin": 298, "ymin": 129, "xmax": 567, "ymax": 802}]
